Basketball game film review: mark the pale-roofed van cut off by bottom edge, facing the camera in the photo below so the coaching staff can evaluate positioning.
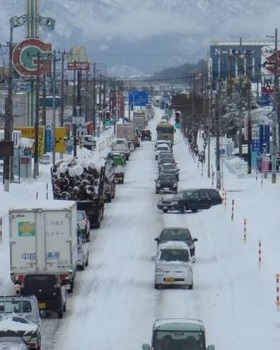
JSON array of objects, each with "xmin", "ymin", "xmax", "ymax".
[{"xmin": 142, "ymin": 318, "xmax": 215, "ymax": 350}]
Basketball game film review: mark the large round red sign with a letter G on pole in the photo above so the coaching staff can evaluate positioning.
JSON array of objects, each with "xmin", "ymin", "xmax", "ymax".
[{"xmin": 12, "ymin": 38, "xmax": 52, "ymax": 76}]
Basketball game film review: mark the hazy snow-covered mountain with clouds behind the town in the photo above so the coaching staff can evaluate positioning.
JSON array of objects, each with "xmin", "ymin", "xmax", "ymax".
[{"xmin": 0, "ymin": 0, "xmax": 280, "ymax": 73}]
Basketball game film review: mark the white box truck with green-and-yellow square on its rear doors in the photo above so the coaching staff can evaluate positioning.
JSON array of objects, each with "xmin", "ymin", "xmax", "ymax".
[{"xmin": 9, "ymin": 200, "xmax": 77, "ymax": 293}]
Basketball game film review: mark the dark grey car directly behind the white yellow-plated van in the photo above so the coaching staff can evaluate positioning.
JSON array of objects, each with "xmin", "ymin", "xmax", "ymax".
[{"xmin": 155, "ymin": 227, "xmax": 198, "ymax": 262}]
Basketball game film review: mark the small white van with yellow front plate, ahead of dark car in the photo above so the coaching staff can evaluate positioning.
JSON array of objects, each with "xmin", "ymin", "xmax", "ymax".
[{"xmin": 155, "ymin": 241, "xmax": 193, "ymax": 289}]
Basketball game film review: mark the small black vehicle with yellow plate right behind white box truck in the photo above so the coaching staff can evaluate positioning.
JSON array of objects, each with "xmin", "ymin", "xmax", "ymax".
[{"xmin": 21, "ymin": 273, "xmax": 66, "ymax": 318}]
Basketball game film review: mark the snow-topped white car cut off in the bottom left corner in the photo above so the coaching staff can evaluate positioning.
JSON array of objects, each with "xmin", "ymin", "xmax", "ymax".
[{"xmin": 0, "ymin": 314, "xmax": 41, "ymax": 350}]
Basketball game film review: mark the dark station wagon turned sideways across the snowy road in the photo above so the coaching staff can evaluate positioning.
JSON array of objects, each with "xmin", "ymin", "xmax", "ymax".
[{"xmin": 157, "ymin": 188, "xmax": 222, "ymax": 213}]
